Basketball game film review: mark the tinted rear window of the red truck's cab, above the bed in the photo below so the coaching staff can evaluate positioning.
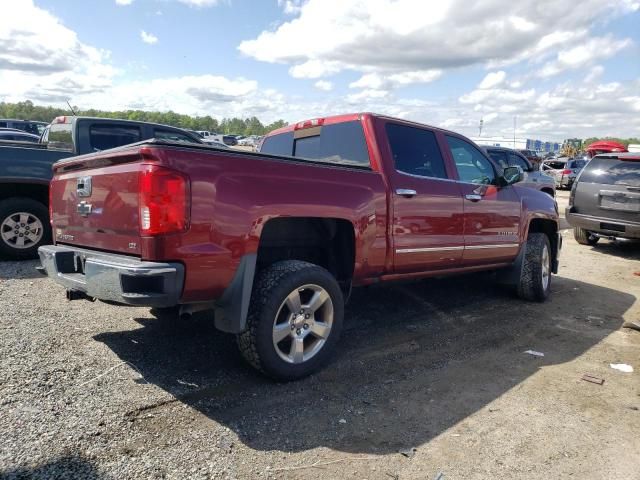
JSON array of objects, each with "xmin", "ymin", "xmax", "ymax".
[{"xmin": 260, "ymin": 120, "xmax": 370, "ymax": 168}]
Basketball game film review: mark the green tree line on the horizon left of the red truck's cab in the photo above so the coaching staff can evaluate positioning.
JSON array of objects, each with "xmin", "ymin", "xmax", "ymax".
[{"xmin": 0, "ymin": 100, "xmax": 287, "ymax": 135}]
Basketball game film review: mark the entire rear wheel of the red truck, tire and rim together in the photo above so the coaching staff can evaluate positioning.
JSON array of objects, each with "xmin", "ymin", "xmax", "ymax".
[{"xmin": 237, "ymin": 260, "xmax": 344, "ymax": 381}]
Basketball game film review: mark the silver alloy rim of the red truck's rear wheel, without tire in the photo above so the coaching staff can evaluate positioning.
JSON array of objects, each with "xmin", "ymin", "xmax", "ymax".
[{"xmin": 272, "ymin": 284, "xmax": 333, "ymax": 364}]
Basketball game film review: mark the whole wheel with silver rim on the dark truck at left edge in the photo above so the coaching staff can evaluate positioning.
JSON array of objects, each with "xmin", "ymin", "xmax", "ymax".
[{"xmin": 0, "ymin": 197, "xmax": 51, "ymax": 259}]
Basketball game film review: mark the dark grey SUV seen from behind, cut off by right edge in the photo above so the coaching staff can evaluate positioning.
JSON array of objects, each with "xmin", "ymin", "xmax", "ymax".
[{"xmin": 566, "ymin": 153, "xmax": 640, "ymax": 245}]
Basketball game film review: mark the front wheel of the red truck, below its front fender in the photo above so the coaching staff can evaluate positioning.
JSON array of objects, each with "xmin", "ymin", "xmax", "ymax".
[{"xmin": 518, "ymin": 233, "xmax": 551, "ymax": 302}]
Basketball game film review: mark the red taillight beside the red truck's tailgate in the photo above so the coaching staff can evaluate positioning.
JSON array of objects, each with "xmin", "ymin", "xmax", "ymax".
[{"xmin": 139, "ymin": 165, "xmax": 191, "ymax": 235}]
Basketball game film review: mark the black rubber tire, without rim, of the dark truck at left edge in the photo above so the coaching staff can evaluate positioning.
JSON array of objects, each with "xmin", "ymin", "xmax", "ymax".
[{"xmin": 0, "ymin": 197, "xmax": 51, "ymax": 259}]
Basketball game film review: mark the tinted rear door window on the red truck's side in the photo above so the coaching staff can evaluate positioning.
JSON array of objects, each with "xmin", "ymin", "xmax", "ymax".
[{"xmin": 386, "ymin": 123, "xmax": 447, "ymax": 178}]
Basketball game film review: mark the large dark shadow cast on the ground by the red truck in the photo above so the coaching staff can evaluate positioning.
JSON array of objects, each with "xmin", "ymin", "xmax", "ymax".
[{"xmin": 95, "ymin": 275, "xmax": 635, "ymax": 454}]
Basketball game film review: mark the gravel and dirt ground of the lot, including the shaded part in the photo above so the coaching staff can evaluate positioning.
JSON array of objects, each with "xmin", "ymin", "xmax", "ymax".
[{"xmin": 0, "ymin": 193, "xmax": 640, "ymax": 480}]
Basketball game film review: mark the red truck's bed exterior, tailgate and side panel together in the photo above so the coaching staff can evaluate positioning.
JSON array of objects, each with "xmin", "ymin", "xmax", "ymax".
[{"xmin": 51, "ymin": 139, "xmax": 387, "ymax": 302}]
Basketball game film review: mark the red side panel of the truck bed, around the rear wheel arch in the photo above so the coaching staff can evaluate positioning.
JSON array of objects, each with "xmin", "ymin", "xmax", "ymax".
[{"xmin": 142, "ymin": 148, "xmax": 387, "ymax": 302}]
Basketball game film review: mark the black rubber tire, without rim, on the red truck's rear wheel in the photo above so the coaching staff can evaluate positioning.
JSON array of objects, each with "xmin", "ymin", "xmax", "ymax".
[{"xmin": 237, "ymin": 260, "xmax": 344, "ymax": 381}]
